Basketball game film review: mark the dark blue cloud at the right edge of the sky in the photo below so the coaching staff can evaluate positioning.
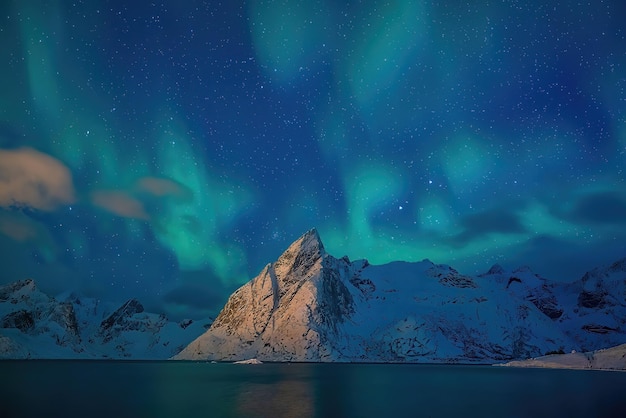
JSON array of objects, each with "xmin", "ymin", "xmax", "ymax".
[{"xmin": 569, "ymin": 191, "xmax": 626, "ymax": 224}]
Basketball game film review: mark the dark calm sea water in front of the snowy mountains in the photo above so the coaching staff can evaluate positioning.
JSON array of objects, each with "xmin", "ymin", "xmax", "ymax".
[{"xmin": 0, "ymin": 360, "xmax": 626, "ymax": 418}]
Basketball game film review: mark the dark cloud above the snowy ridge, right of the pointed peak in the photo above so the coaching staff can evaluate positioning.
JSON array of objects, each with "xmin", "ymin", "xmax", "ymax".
[{"xmin": 449, "ymin": 208, "xmax": 527, "ymax": 246}]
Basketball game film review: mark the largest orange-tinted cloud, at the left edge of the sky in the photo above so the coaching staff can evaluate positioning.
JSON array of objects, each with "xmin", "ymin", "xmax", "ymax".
[{"xmin": 0, "ymin": 148, "xmax": 75, "ymax": 211}]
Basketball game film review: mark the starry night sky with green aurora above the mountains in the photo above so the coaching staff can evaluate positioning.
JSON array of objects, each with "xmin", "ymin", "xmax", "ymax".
[{"xmin": 0, "ymin": 0, "xmax": 626, "ymax": 318}]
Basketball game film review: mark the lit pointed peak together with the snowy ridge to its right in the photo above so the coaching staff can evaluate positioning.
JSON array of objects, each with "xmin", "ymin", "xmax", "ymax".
[{"xmin": 174, "ymin": 229, "xmax": 626, "ymax": 363}]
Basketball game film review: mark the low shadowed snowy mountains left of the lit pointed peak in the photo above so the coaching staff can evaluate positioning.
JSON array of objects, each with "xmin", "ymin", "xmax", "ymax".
[{"xmin": 0, "ymin": 279, "xmax": 211, "ymax": 359}]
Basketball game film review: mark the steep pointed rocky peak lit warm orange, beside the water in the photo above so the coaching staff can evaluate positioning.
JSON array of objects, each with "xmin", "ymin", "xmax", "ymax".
[{"xmin": 175, "ymin": 229, "xmax": 354, "ymax": 361}]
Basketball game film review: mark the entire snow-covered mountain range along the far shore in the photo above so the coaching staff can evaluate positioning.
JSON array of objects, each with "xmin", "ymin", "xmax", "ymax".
[{"xmin": 0, "ymin": 229, "xmax": 626, "ymax": 364}]
